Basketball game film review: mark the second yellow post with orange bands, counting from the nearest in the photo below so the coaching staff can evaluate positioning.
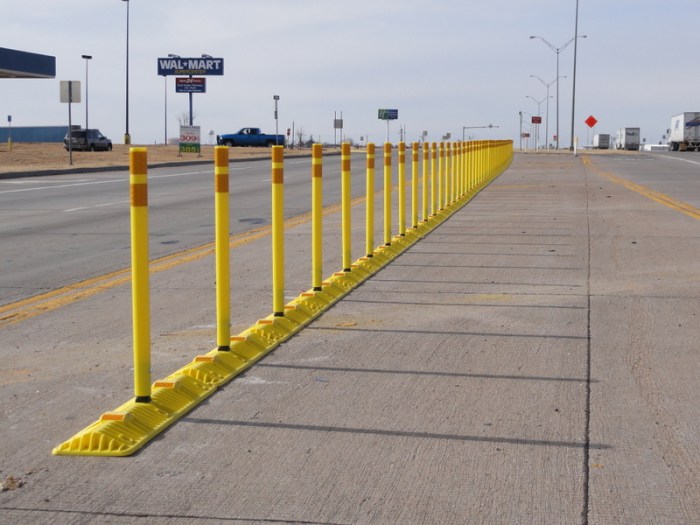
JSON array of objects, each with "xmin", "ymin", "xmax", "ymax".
[{"xmin": 214, "ymin": 146, "xmax": 231, "ymax": 352}]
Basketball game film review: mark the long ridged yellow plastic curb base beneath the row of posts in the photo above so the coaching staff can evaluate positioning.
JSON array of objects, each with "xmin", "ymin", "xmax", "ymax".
[{"xmin": 53, "ymin": 168, "xmax": 505, "ymax": 456}]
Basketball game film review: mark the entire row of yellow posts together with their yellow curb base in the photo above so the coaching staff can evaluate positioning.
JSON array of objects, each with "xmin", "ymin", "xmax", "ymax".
[{"xmin": 53, "ymin": 141, "xmax": 513, "ymax": 456}]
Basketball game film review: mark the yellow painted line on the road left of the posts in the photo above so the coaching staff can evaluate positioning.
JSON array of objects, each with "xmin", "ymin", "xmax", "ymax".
[{"xmin": 0, "ymin": 197, "xmax": 365, "ymax": 328}]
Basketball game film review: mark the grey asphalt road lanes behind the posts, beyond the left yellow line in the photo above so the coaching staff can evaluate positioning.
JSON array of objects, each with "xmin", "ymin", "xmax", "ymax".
[{"xmin": 0, "ymin": 154, "xmax": 372, "ymax": 304}]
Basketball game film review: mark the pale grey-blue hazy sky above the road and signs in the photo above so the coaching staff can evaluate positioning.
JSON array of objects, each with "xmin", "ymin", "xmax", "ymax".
[{"xmin": 0, "ymin": 0, "xmax": 700, "ymax": 148}]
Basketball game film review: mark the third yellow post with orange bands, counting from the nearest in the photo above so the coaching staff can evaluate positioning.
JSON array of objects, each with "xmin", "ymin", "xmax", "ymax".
[{"xmin": 272, "ymin": 146, "xmax": 284, "ymax": 317}]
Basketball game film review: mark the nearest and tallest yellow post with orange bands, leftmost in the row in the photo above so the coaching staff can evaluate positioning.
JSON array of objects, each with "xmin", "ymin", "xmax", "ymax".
[{"xmin": 129, "ymin": 148, "xmax": 151, "ymax": 403}]
